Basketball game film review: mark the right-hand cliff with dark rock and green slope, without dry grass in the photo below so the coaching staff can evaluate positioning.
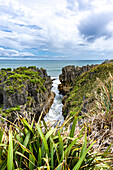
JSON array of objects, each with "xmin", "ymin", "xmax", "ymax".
[{"xmin": 59, "ymin": 63, "xmax": 113, "ymax": 117}]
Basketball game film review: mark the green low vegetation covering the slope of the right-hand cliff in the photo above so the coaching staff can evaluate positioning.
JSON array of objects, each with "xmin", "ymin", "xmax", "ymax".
[{"xmin": 66, "ymin": 63, "xmax": 113, "ymax": 114}]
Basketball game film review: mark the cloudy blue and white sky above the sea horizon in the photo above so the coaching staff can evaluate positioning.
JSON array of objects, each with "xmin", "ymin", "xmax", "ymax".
[{"xmin": 0, "ymin": 0, "xmax": 113, "ymax": 60}]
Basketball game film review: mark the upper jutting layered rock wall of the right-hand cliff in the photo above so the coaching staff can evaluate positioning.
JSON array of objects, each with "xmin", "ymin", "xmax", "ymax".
[{"xmin": 58, "ymin": 65, "xmax": 96, "ymax": 95}]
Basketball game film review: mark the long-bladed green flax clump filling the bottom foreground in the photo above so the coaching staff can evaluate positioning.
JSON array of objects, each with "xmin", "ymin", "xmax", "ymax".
[{"xmin": 0, "ymin": 111, "xmax": 112, "ymax": 170}]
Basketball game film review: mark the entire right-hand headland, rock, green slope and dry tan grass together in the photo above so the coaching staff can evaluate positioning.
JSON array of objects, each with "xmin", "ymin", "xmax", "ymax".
[{"xmin": 60, "ymin": 62, "xmax": 113, "ymax": 153}]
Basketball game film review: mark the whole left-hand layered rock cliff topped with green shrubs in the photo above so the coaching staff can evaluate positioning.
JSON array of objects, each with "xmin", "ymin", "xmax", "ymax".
[{"xmin": 0, "ymin": 66, "xmax": 55, "ymax": 119}]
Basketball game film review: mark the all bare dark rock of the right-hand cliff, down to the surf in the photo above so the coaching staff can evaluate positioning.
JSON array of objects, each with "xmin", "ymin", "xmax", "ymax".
[{"xmin": 58, "ymin": 65, "xmax": 97, "ymax": 118}]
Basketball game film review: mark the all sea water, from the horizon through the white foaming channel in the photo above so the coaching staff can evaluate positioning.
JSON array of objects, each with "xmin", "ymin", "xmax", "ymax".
[{"xmin": 0, "ymin": 60, "xmax": 103, "ymax": 123}]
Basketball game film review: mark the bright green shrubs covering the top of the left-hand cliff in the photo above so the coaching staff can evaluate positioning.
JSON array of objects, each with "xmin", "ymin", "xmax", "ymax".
[{"xmin": 0, "ymin": 66, "xmax": 47, "ymax": 113}]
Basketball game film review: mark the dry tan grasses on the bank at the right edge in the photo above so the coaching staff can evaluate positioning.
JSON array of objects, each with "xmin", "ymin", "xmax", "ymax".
[{"xmin": 82, "ymin": 74, "xmax": 113, "ymax": 169}]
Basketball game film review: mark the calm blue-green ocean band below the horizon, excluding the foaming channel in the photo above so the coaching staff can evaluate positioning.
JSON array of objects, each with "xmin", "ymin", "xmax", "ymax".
[{"xmin": 0, "ymin": 60, "xmax": 103, "ymax": 77}]
